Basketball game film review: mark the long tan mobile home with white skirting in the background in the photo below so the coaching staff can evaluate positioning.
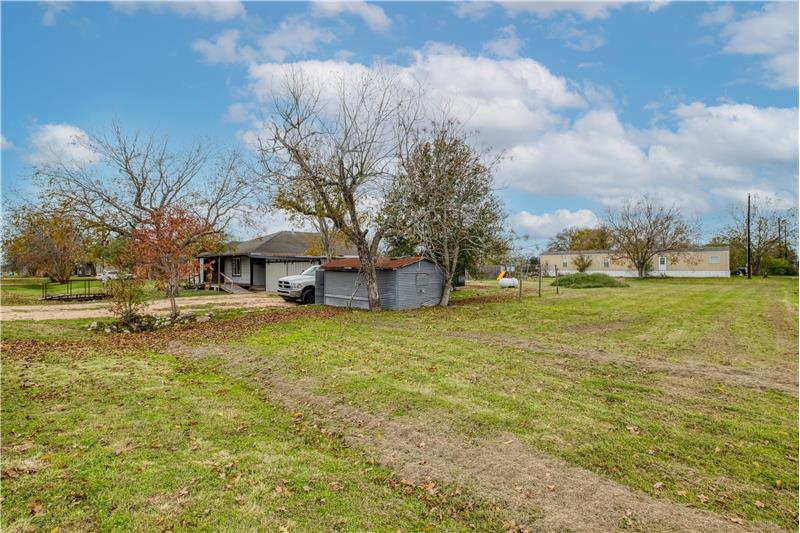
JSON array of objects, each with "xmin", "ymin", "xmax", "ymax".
[{"xmin": 539, "ymin": 246, "xmax": 731, "ymax": 278}]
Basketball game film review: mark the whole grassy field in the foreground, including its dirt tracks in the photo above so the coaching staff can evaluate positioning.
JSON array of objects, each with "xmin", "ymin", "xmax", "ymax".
[{"xmin": 2, "ymin": 278, "xmax": 798, "ymax": 531}]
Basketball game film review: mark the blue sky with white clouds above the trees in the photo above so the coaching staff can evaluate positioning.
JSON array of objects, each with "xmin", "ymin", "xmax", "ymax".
[{"xmin": 0, "ymin": 1, "xmax": 798, "ymax": 247}]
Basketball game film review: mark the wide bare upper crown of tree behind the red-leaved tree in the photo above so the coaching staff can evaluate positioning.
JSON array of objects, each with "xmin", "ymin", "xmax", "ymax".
[{"xmin": 34, "ymin": 124, "xmax": 253, "ymax": 236}]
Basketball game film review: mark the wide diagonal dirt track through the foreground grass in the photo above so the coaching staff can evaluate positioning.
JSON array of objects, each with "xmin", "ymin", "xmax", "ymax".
[{"xmin": 169, "ymin": 344, "xmax": 779, "ymax": 531}]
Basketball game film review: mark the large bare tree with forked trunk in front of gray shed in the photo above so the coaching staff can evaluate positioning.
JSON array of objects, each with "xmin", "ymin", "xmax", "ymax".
[{"xmin": 259, "ymin": 69, "xmax": 417, "ymax": 310}]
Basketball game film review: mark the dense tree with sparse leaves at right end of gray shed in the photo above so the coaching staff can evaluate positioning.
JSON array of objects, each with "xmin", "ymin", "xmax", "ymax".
[{"xmin": 387, "ymin": 119, "xmax": 506, "ymax": 306}]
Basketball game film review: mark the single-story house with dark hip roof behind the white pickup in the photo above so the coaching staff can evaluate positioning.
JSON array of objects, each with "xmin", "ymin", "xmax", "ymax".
[{"xmin": 199, "ymin": 231, "xmax": 356, "ymax": 292}]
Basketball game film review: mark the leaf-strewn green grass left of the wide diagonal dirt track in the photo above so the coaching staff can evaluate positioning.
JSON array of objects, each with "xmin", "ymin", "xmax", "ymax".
[{"xmin": 0, "ymin": 352, "xmax": 503, "ymax": 531}]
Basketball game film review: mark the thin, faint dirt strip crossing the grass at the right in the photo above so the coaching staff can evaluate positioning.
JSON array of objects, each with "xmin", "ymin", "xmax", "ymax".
[{"xmin": 446, "ymin": 332, "xmax": 798, "ymax": 396}]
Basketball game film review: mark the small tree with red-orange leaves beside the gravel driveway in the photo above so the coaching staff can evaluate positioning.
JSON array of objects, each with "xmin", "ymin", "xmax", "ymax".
[{"xmin": 129, "ymin": 207, "xmax": 222, "ymax": 318}]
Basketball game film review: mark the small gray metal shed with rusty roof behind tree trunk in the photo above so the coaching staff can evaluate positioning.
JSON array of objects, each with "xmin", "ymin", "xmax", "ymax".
[{"xmin": 314, "ymin": 256, "xmax": 444, "ymax": 310}]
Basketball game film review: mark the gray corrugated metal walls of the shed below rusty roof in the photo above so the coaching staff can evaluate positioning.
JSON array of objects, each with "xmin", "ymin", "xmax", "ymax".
[{"xmin": 315, "ymin": 261, "xmax": 443, "ymax": 310}]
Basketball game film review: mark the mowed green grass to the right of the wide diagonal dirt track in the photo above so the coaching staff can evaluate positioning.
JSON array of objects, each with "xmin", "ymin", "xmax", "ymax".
[{"xmin": 241, "ymin": 280, "xmax": 798, "ymax": 529}]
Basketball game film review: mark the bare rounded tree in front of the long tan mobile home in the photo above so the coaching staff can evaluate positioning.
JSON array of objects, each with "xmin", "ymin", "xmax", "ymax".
[{"xmin": 606, "ymin": 196, "xmax": 699, "ymax": 277}]
